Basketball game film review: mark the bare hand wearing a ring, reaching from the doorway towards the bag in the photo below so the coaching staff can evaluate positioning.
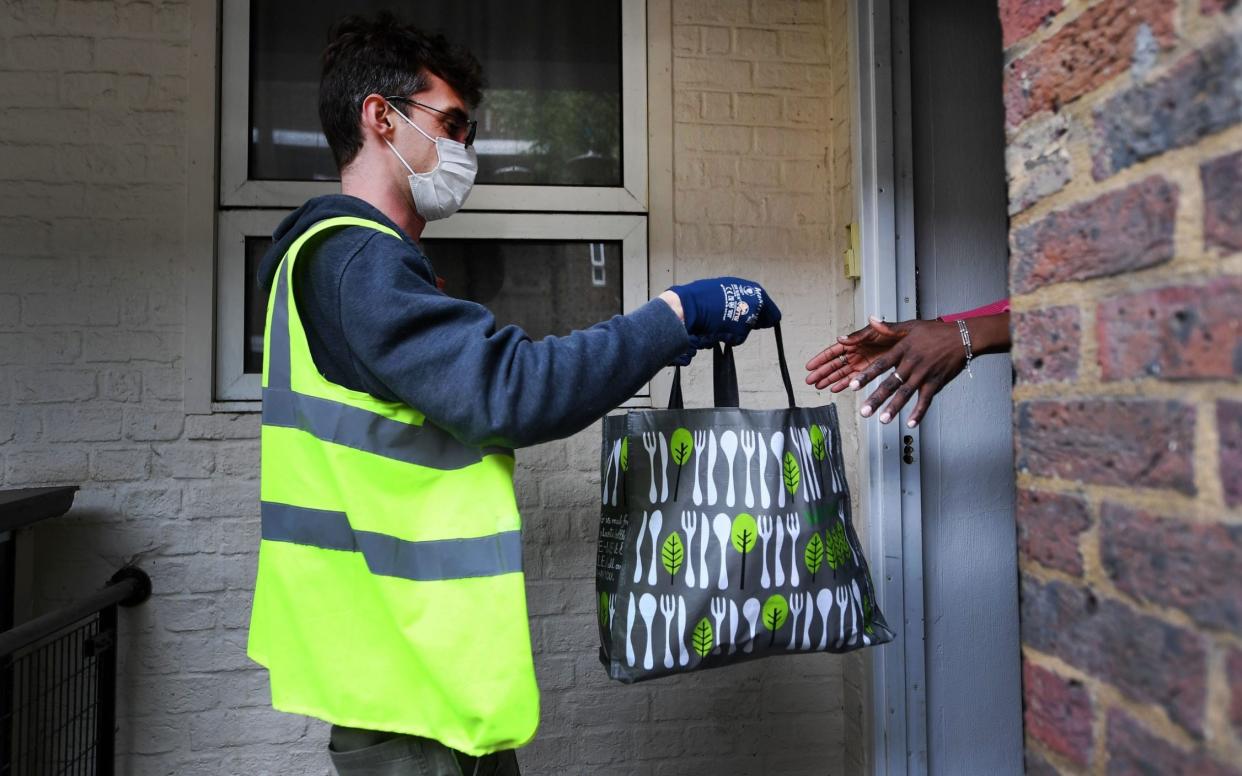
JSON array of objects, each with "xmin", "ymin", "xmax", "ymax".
[{"xmin": 806, "ymin": 317, "xmax": 966, "ymax": 428}]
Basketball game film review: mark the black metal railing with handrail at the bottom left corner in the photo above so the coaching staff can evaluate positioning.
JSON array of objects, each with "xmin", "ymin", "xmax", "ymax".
[{"xmin": 0, "ymin": 566, "xmax": 152, "ymax": 776}]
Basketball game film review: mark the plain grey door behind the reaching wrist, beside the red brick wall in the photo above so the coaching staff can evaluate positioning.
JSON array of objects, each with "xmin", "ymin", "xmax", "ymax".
[{"xmin": 908, "ymin": 0, "xmax": 1022, "ymax": 776}]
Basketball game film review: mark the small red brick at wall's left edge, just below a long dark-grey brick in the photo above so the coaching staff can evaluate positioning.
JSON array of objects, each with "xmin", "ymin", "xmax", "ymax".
[{"xmin": 1022, "ymin": 661, "xmax": 1093, "ymax": 767}]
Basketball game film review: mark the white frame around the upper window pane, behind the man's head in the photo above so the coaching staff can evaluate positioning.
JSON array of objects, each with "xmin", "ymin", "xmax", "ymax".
[{"xmin": 220, "ymin": 0, "xmax": 648, "ymax": 212}]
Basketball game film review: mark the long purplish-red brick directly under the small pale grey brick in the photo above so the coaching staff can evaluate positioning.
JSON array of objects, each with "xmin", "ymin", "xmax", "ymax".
[{"xmin": 1010, "ymin": 176, "xmax": 1179, "ymax": 293}]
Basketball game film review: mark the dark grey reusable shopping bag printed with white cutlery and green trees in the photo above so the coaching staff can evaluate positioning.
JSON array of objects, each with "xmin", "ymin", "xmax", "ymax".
[{"xmin": 596, "ymin": 327, "xmax": 893, "ymax": 683}]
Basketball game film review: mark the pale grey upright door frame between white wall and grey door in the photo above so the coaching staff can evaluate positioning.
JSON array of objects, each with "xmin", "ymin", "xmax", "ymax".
[{"xmin": 850, "ymin": 0, "xmax": 928, "ymax": 776}]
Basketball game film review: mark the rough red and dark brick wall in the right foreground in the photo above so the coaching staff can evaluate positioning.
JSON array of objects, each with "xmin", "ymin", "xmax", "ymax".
[{"xmin": 1000, "ymin": 0, "xmax": 1242, "ymax": 775}]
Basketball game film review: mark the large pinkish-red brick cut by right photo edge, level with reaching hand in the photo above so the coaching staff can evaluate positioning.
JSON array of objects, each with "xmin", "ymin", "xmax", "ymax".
[{"xmin": 1095, "ymin": 277, "xmax": 1242, "ymax": 380}]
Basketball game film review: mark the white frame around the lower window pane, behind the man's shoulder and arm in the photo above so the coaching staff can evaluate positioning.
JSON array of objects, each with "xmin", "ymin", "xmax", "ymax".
[{"xmin": 214, "ymin": 209, "xmax": 651, "ymax": 399}]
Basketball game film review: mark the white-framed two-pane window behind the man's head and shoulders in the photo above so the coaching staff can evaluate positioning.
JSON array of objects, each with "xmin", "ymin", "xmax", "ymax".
[{"xmin": 211, "ymin": 0, "xmax": 648, "ymax": 402}]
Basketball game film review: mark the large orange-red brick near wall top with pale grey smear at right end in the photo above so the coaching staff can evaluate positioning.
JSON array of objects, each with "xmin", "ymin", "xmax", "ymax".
[{"xmin": 1005, "ymin": 0, "xmax": 1177, "ymax": 127}]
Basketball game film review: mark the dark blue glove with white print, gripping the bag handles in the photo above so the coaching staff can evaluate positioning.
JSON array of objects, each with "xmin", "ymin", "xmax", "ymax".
[{"xmin": 669, "ymin": 277, "xmax": 780, "ymax": 350}]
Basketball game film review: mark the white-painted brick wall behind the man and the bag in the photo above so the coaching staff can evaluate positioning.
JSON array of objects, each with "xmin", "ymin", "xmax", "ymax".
[{"xmin": 0, "ymin": 0, "xmax": 859, "ymax": 776}]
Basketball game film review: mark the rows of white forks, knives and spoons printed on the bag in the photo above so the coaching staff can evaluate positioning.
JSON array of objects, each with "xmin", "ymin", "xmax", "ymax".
[{"xmin": 600, "ymin": 426, "xmax": 874, "ymax": 672}]
